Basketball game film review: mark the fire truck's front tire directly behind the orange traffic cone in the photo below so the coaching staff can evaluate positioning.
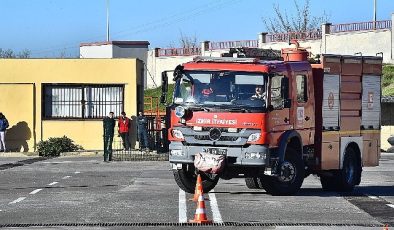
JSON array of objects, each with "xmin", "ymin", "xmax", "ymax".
[{"xmin": 173, "ymin": 165, "xmax": 219, "ymax": 194}]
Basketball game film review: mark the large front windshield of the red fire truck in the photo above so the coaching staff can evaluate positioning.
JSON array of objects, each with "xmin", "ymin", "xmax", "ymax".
[{"xmin": 174, "ymin": 71, "xmax": 267, "ymax": 108}]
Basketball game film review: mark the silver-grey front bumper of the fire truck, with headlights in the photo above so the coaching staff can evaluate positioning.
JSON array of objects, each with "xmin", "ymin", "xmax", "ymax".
[{"xmin": 169, "ymin": 142, "xmax": 269, "ymax": 166}]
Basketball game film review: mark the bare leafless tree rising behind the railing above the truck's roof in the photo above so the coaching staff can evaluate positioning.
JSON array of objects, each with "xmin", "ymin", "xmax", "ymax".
[{"xmin": 263, "ymin": 0, "xmax": 329, "ymax": 33}]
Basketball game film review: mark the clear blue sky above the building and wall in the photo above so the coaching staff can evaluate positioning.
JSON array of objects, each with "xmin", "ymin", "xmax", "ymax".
[{"xmin": 0, "ymin": 0, "xmax": 394, "ymax": 57}]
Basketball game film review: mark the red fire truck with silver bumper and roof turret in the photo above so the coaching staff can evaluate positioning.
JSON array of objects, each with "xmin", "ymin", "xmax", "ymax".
[{"xmin": 162, "ymin": 42, "xmax": 382, "ymax": 195}]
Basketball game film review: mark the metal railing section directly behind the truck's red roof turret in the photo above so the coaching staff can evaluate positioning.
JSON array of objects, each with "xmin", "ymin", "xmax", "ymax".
[{"xmin": 266, "ymin": 30, "xmax": 322, "ymax": 42}]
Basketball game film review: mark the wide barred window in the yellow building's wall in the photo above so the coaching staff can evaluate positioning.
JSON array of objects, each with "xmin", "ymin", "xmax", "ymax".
[{"xmin": 43, "ymin": 85, "xmax": 124, "ymax": 119}]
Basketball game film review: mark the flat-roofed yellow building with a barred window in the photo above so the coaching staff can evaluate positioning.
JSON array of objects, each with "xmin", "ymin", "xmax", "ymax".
[{"xmin": 0, "ymin": 59, "xmax": 144, "ymax": 152}]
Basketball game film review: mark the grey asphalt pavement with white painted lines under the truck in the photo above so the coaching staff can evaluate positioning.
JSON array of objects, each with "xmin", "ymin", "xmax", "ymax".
[{"xmin": 0, "ymin": 154, "xmax": 394, "ymax": 230}]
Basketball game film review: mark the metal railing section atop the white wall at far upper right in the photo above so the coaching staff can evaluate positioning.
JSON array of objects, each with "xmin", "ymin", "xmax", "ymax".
[{"xmin": 330, "ymin": 20, "xmax": 392, "ymax": 33}]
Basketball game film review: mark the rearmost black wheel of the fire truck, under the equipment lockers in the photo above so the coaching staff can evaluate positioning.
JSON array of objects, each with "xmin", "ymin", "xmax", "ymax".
[{"xmin": 320, "ymin": 148, "xmax": 362, "ymax": 192}]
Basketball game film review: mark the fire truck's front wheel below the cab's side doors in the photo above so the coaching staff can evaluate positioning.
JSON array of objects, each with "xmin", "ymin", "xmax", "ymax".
[{"xmin": 261, "ymin": 147, "xmax": 305, "ymax": 196}]
